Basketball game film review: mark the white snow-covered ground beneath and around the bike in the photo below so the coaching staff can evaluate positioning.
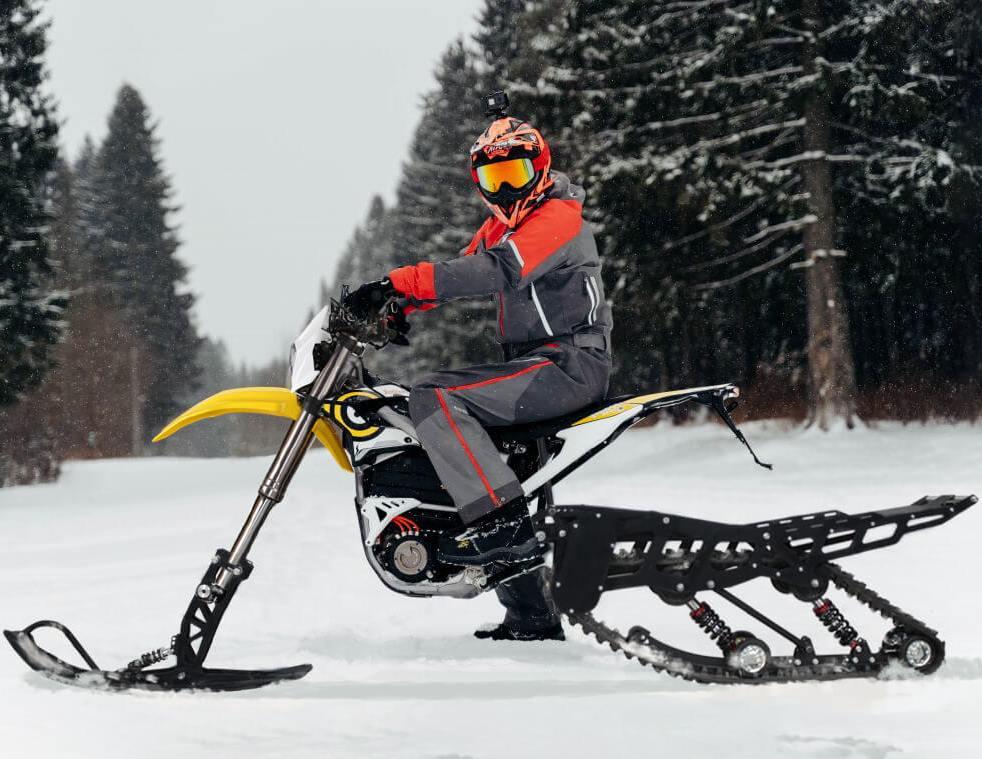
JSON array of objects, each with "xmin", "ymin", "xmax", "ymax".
[{"xmin": 0, "ymin": 425, "xmax": 982, "ymax": 759}]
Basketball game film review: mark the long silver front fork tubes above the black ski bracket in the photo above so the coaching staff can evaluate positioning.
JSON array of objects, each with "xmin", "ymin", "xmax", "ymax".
[{"xmin": 215, "ymin": 336, "xmax": 361, "ymax": 592}]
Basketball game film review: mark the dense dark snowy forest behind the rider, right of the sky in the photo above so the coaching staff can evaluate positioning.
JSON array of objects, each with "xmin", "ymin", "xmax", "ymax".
[{"xmin": 328, "ymin": 0, "xmax": 982, "ymax": 428}]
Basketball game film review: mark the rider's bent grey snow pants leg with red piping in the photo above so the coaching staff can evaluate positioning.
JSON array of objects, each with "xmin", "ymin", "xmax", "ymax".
[{"xmin": 409, "ymin": 339, "xmax": 610, "ymax": 524}]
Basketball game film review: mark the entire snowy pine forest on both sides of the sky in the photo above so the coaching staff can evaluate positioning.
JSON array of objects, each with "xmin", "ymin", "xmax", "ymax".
[{"xmin": 0, "ymin": 0, "xmax": 982, "ymax": 485}]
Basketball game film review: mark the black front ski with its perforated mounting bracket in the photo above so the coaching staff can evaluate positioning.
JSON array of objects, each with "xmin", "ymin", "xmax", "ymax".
[{"xmin": 3, "ymin": 549, "xmax": 311, "ymax": 691}]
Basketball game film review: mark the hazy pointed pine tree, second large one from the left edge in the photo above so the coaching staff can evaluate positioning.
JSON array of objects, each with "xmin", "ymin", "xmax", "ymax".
[{"xmin": 89, "ymin": 85, "xmax": 198, "ymax": 437}]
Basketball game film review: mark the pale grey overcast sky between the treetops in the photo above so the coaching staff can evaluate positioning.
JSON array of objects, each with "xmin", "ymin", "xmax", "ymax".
[{"xmin": 46, "ymin": 0, "xmax": 480, "ymax": 364}]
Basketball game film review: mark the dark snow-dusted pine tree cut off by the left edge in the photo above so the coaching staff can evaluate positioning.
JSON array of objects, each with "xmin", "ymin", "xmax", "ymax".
[{"xmin": 0, "ymin": 0, "xmax": 66, "ymax": 406}]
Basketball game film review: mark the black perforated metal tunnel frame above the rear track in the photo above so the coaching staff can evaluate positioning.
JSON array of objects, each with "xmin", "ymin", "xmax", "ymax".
[{"xmin": 536, "ymin": 495, "xmax": 977, "ymax": 614}]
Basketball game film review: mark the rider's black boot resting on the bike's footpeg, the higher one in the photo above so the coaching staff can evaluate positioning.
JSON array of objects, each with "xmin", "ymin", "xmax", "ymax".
[{"xmin": 439, "ymin": 498, "xmax": 546, "ymax": 566}]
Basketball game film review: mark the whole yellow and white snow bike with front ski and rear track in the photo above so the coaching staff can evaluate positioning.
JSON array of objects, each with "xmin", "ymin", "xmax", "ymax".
[{"xmin": 4, "ymin": 296, "xmax": 976, "ymax": 691}]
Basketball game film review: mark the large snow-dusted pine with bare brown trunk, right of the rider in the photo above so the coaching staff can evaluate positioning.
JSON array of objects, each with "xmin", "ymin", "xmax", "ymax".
[{"xmin": 546, "ymin": 0, "xmax": 970, "ymax": 428}]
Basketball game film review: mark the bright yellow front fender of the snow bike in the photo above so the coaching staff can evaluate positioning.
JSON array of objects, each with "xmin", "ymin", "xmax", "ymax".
[{"xmin": 153, "ymin": 387, "xmax": 351, "ymax": 472}]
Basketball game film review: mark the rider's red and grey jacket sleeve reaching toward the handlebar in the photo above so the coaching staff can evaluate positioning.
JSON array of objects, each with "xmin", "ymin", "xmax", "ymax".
[{"xmin": 389, "ymin": 200, "xmax": 583, "ymax": 301}]
